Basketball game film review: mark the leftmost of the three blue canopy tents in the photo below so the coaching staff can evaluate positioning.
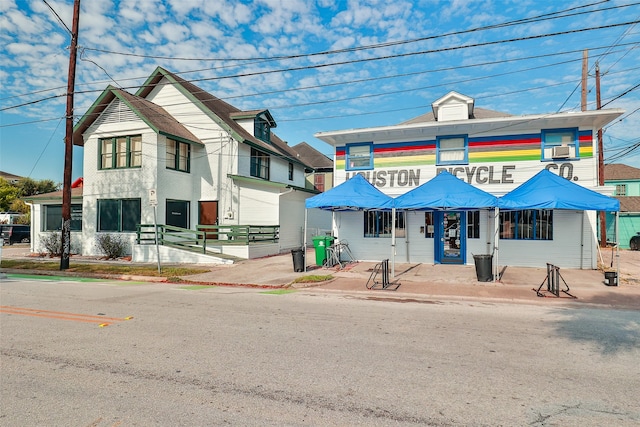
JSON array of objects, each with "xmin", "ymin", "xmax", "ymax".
[{"xmin": 302, "ymin": 174, "xmax": 395, "ymax": 271}]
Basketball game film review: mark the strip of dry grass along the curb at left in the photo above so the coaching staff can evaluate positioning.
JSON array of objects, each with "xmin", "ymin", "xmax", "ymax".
[{"xmin": 0, "ymin": 260, "xmax": 209, "ymax": 277}]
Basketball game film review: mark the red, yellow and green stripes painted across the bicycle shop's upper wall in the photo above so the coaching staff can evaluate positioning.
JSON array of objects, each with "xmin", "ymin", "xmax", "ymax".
[{"xmin": 335, "ymin": 131, "xmax": 593, "ymax": 169}]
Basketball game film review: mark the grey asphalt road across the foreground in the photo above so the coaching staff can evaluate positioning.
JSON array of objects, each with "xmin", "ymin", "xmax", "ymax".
[{"xmin": 0, "ymin": 276, "xmax": 640, "ymax": 427}]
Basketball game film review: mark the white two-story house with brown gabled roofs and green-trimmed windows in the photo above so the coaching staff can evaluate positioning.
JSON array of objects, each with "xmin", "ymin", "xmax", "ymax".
[{"xmin": 32, "ymin": 67, "xmax": 326, "ymax": 262}]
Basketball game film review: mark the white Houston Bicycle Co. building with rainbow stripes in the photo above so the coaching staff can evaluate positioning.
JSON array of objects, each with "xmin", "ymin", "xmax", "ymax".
[{"xmin": 315, "ymin": 92, "xmax": 623, "ymax": 268}]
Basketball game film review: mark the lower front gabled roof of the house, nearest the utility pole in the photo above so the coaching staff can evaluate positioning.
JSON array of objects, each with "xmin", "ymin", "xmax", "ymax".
[{"xmin": 73, "ymin": 85, "xmax": 202, "ymax": 146}]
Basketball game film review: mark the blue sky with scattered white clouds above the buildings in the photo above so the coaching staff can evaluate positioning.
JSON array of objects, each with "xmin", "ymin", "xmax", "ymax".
[{"xmin": 0, "ymin": 0, "xmax": 640, "ymax": 183}]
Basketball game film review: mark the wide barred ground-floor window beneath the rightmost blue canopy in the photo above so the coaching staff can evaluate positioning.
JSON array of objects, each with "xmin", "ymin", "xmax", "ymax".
[{"xmin": 500, "ymin": 209, "xmax": 553, "ymax": 240}]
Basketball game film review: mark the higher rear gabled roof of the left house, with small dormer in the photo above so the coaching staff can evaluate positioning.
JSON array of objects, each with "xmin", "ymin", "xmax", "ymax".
[{"xmin": 136, "ymin": 67, "xmax": 307, "ymax": 166}]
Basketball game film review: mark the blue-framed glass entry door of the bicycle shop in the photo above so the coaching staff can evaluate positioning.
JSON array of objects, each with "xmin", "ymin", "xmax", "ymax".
[{"xmin": 435, "ymin": 211, "xmax": 466, "ymax": 264}]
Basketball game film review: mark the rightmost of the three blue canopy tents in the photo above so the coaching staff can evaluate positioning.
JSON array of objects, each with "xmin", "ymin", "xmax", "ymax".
[{"xmin": 498, "ymin": 169, "xmax": 620, "ymax": 280}]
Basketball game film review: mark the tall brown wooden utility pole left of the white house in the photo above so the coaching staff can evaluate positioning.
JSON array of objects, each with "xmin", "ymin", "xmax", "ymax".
[{"xmin": 60, "ymin": 0, "xmax": 80, "ymax": 270}]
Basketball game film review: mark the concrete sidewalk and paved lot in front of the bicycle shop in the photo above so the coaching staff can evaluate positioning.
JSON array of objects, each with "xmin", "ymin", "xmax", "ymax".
[{"xmin": 2, "ymin": 245, "xmax": 640, "ymax": 309}]
